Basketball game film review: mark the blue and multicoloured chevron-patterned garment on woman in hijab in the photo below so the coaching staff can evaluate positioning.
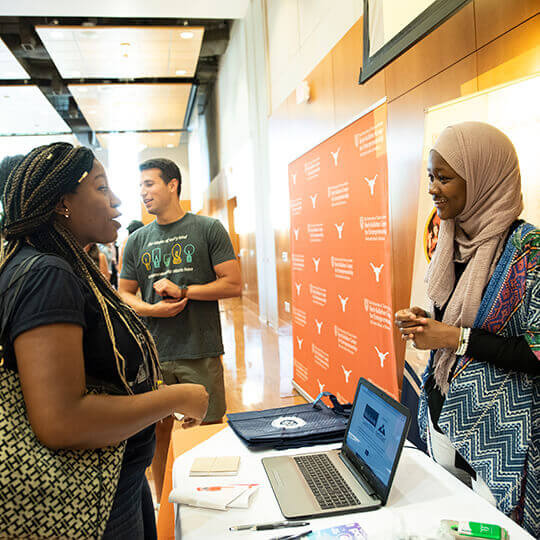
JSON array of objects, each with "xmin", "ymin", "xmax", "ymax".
[{"xmin": 418, "ymin": 223, "xmax": 540, "ymax": 538}]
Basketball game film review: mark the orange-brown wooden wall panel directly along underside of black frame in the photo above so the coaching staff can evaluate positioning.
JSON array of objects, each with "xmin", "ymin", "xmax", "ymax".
[{"xmin": 384, "ymin": 3, "xmax": 475, "ymax": 100}]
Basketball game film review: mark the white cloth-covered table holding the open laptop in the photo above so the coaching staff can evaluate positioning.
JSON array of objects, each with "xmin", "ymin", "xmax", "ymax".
[{"xmin": 173, "ymin": 427, "xmax": 534, "ymax": 540}]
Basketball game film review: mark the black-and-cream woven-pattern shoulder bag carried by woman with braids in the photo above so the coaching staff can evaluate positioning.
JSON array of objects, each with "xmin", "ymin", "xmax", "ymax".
[{"xmin": 0, "ymin": 254, "xmax": 125, "ymax": 539}]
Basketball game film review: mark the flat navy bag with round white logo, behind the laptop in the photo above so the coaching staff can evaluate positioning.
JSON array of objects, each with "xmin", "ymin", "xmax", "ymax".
[{"xmin": 227, "ymin": 392, "xmax": 352, "ymax": 450}]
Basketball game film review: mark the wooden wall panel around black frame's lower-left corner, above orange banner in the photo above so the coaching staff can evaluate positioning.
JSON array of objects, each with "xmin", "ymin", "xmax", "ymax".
[{"xmin": 330, "ymin": 17, "xmax": 386, "ymax": 129}]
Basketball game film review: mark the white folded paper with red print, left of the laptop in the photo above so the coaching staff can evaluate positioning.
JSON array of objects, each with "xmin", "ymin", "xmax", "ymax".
[{"xmin": 169, "ymin": 484, "xmax": 259, "ymax": 510}]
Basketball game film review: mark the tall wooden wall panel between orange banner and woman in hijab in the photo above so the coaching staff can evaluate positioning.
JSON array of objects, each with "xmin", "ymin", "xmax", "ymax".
[{"xmin": 387, "ymin": 55, "xmax": 476, "ymax": 384}]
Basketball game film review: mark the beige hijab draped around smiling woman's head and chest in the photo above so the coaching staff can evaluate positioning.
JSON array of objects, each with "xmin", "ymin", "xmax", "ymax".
[{"xmin": 426, "ymin": 122, "xmax": 523, "ymax": 394}]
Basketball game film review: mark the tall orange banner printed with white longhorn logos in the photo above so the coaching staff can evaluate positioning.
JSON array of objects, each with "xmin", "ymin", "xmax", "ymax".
[{"xmin": 289, "ymin": 104, "xmax": 398, "ymax": 402}]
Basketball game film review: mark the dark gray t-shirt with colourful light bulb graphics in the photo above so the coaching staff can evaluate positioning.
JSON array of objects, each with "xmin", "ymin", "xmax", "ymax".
[{"xmin": 120, "ymin": 213, "xmax": 236, "ymax": 362}]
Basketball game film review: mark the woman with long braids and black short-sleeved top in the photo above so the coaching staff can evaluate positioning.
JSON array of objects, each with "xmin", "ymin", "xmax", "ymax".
[{"xmin": 0, "ymin": 143, "xmax": 208, "ymax": 540}]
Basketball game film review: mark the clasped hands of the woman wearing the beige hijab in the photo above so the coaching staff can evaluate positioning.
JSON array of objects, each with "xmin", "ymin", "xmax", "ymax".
[{"xmin": 395, "ymin": 307, "xmax": 459, "ymax": 350}]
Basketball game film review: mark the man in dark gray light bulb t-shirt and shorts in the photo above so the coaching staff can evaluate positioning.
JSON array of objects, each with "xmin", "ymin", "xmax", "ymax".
[{"xmin": 119, "ymin": 159, "xmax": 241, "ymax": 500}]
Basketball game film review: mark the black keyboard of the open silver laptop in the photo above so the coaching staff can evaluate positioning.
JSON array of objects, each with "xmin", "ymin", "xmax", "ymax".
[{"xmin": 294, "ymin": 454, "xmax": 360, "ymax": 510}]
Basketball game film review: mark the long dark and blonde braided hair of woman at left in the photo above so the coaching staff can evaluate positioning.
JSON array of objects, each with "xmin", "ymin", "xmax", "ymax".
[{"xmin": 0, "ymin": 143, "xmax": 160, "ymax": 394}]
